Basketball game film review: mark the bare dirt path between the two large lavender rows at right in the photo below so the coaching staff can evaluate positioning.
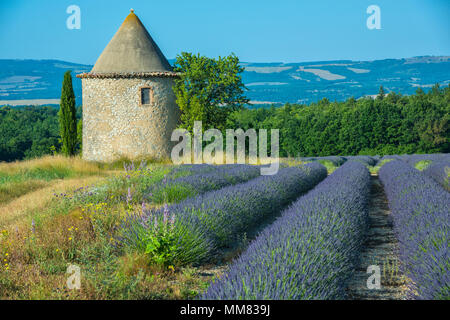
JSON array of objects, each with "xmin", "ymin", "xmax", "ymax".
[{"xmin": 347, "ymin": 176, "xmax": 407, "ymax": 300}]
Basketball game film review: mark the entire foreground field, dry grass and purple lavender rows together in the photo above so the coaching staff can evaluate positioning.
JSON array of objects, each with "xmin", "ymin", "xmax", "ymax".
[{"xmin": 0, "ymin": 154, "xmax": 450, "ymax": 300}]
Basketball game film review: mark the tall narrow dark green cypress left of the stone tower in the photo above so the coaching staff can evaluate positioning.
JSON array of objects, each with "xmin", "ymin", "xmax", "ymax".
[{"xmin": 59, "ymin": 70, "xmax": 77, "ymax": 156}]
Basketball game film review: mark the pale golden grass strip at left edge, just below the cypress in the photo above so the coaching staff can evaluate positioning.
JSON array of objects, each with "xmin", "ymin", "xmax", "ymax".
[{"xmin": 0, "ymin": 155, "xmax": 121, "ymax": 222}]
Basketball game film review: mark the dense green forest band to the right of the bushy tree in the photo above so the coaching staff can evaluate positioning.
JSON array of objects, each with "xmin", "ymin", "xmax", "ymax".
[{"xmin": 227, "ymin": 85, "xmax": 450, "ymax": 156}]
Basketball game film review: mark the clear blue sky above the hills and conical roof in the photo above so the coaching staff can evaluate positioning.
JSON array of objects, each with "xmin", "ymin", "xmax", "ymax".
[{"xmin": 0, "ymin": 0, "xmax": 450, "ymax": 64}]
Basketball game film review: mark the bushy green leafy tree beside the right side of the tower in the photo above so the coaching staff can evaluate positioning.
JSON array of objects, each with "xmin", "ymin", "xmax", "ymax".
[{"xmin": 174, "ymin": 52, "xmax": 249, "ymax": 131}]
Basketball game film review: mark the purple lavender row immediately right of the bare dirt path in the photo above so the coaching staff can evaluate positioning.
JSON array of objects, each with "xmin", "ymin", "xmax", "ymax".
[{"xmin": 379, "ymin": 161, "xmax": 450, "ymax": 299}]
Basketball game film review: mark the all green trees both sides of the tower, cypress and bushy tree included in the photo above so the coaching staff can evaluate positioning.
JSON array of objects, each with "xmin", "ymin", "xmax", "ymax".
[{"xmin": 0, "ymin": 53, "xmax": 450, "ymax": 161}]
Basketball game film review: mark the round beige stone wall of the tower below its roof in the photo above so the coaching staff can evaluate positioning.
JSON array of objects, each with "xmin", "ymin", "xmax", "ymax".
[{"xmin": 82, "ymin": 77, "xmax": 180, "ymax": 162}]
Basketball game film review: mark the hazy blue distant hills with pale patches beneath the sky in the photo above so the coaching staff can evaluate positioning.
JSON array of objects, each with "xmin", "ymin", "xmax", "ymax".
[{"xmin": 0, "ymin": 56, "xmax": 450, "ymax": 106}]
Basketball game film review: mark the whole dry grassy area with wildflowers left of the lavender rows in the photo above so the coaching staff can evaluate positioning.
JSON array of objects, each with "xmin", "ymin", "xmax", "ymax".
[{"xmin": 0, "ymin": 156, "xmax": 209, "ymax": 299}]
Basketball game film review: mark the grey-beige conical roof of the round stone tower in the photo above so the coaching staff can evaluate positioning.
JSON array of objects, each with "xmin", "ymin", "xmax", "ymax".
[{"xmin": 91, "ymin": 10, "xmax": 172, "ymax": 74}]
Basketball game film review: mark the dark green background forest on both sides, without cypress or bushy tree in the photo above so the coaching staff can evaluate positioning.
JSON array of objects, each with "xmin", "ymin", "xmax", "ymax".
[{"xmin": 0, "ymin": 85, "xmax": 450, "ymax": 161}]
